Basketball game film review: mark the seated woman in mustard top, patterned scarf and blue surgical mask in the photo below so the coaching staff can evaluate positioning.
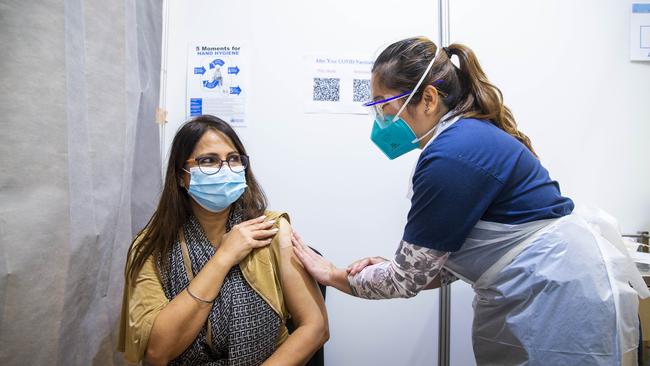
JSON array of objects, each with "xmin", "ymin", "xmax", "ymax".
[{"xmin": 118, "ymin": 115, "xmax": 329, "ymax": 365}]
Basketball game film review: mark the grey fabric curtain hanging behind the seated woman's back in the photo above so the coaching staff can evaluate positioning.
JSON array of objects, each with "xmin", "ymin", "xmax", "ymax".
[{"xmin": 0, "ymin": 0, "xmax": 162, "ymax": 365}]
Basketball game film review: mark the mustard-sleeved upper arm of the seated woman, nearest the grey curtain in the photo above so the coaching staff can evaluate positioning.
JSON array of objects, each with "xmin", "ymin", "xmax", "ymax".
[{"xmin": 122, "ymin": 253, "xmax": 169, "ymax": 361}]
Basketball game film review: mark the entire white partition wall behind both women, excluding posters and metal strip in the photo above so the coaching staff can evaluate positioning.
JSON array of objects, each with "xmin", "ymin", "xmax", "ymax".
[{"xmin": 159, "ymin": 0, "xmax": 650, "ymax": 366}]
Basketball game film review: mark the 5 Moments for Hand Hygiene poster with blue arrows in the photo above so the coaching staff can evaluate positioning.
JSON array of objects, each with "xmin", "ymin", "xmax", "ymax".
[{"xmin": 186, "ymin": 44, "xmax": 248, "ymax": 127}]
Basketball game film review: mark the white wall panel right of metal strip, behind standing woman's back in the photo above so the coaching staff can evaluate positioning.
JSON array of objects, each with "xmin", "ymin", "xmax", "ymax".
[{"xmin": 451, "ymin": 0, "xmax": 650, "ymax": 232}]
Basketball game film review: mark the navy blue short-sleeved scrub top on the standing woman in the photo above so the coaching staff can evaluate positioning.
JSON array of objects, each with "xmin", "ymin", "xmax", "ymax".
[{"xmin": 403, "ymin": 119, "xmax": 574, "ymax": 252}]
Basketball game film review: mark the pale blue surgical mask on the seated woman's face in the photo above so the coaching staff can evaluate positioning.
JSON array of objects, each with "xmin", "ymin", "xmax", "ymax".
[{"xmin": 187, "ymin": 164, "xmax": 247, "ymax": 212}]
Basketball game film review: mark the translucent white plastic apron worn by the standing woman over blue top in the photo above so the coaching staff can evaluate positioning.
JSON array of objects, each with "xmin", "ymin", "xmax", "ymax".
[{"xmin": 407, "ymin": 117, "xmax": 650, "ymax": 366}]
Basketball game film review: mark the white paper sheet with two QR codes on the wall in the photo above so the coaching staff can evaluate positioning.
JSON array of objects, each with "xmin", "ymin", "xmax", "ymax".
[{"xmin": 303, "ymin": 55, "xmax": 372, "ymax": 114}]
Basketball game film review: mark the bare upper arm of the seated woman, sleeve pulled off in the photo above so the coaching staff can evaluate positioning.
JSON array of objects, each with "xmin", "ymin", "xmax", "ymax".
[{"xmin": 277, "ymin": 218, "xmax": 327, "ymax": 328}]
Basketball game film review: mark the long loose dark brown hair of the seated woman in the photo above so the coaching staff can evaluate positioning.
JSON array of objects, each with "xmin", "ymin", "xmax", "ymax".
[{"xmin": 125, "ymin": 115, "xmax": 267, "ymax": 284}]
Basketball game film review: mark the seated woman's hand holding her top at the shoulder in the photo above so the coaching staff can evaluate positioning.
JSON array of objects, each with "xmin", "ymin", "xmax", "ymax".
[{"xmin": 216, "ymin": 216, "xmax": 278, "ymax": 267}]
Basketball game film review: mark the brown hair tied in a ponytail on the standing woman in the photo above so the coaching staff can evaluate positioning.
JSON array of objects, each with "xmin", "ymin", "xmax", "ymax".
[{"xmin": 372, "ymin": 37, "xmax": 537, "ymax": 156}]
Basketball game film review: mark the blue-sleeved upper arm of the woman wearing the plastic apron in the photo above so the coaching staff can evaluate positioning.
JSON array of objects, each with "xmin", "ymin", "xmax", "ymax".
[{"xmin": 403, "ymin": 154, "xmax": 502, "ymax": 252}]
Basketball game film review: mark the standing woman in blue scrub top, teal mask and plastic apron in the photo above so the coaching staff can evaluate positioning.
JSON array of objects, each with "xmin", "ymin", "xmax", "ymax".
[{"xmin": 293, "ymin": 38, "xmax": 648, "ymax": 366}]
